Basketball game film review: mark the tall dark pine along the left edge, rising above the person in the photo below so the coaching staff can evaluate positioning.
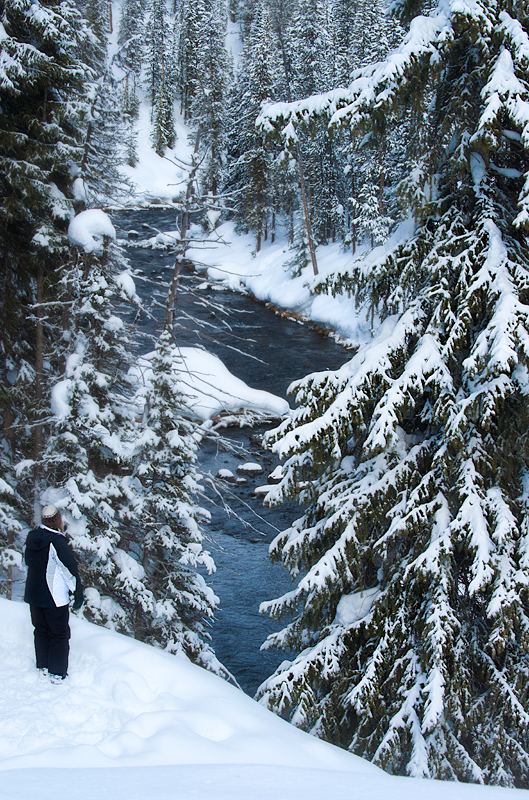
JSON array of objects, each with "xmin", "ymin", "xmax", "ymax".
[{"xmin": 0, "ymin": 0, "xmax": 91, "ymax": 549}]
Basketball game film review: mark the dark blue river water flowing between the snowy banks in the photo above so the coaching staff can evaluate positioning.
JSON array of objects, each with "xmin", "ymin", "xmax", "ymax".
[{"xmin": 113, "ymin": 209, "xmax": 348, "ymax": 695}]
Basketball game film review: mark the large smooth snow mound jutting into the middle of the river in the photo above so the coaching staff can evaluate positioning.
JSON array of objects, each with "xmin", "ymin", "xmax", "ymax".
[{"xmin": 129, "ymin": 347, "xmax": 289, "ymax": 421}]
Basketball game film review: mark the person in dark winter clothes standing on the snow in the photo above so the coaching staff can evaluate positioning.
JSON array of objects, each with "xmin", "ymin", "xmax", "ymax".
[{"xmin": 24, "ymin": 506, "xmax": 83, "ymax": 683}]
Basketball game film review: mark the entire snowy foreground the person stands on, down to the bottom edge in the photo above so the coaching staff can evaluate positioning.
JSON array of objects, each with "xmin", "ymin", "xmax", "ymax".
[{"xmin": 0, "ymin": 599, "xmax": 516, "ymax": 800}]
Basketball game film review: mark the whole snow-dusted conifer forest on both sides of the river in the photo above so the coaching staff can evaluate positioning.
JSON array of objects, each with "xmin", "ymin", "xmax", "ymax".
[{"xmin": 0, "ymin": 0, "xmax": 529, "ymax": 789}]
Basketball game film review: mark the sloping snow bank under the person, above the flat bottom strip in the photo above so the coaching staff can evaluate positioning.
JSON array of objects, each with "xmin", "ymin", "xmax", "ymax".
[{"xmin": 0, "ymin": 599, "xmax": 379, "ymax": 776}]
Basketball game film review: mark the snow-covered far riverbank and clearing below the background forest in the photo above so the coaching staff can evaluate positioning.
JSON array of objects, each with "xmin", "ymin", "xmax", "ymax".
[{"xmin": 118, "ymin": 97, "xmax": 413, "ymax": 349}]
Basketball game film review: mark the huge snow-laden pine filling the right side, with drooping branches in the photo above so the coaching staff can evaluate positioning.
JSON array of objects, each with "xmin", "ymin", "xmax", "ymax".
[{"xmin": 260, "ymin": 0, "xmax": 529, "ymax": 788}]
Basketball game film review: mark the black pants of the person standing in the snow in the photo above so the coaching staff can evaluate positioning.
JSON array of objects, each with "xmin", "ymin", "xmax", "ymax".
[{"xmin": 30, "ymin": 606, "xmax": 70, "ymax": 675}]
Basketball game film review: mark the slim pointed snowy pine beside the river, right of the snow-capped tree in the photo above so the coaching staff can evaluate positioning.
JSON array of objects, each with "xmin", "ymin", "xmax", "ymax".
[{"xmin": 133, "ymin": 331, "xmax": 226, "ymax": 674}]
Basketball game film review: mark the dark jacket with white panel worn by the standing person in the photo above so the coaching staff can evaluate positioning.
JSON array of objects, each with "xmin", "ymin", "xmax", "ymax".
[{"xmin": 24, "ymin": 525, "xmax": 83, "ymax": 608}]
